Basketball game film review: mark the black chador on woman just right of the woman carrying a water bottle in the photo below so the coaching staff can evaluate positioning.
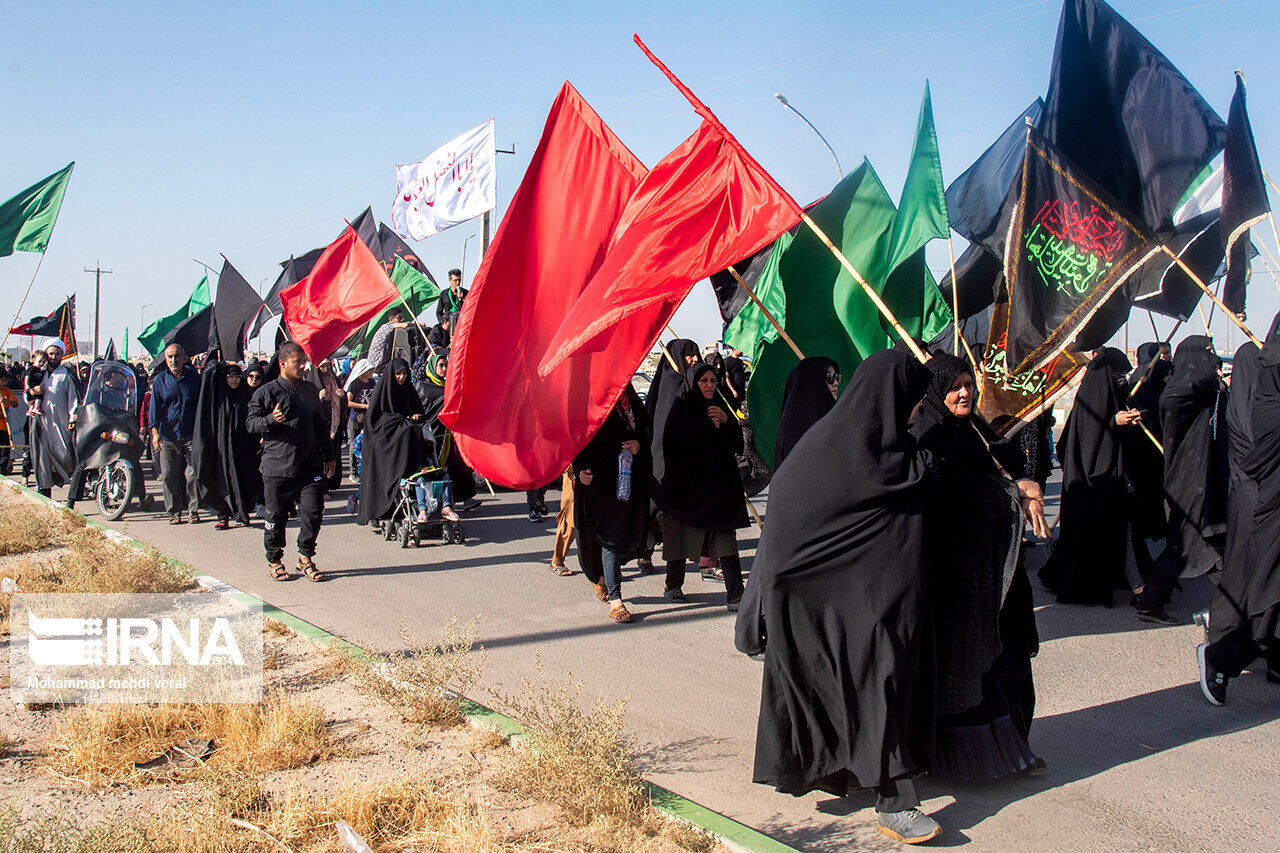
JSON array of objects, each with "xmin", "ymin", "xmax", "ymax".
[{"xmin": 654, "ymin": 362, "xmax": 748, "ymax": 532}]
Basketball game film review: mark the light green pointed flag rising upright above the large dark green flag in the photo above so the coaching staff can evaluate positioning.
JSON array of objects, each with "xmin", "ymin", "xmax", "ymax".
[{"xmin": 888, "ymin": 82, "xmax": 951, "ymax": 270}]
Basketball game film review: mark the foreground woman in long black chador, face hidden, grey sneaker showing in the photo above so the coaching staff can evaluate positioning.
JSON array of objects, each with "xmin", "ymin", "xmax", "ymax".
[{"xmin": 736, "ymin": 350, "xmax": 940, "ymax": 843}]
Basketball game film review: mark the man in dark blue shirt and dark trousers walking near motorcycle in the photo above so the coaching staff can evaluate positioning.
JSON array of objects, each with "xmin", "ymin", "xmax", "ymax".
[{"xmin": 148, "ymin": 343, "xmax": 200, "ymax": 524}]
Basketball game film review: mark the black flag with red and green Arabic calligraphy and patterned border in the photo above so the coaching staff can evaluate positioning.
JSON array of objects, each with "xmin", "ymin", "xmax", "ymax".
[{"xmin": 1005, "ymin": 131, "xmax": 1160, "ymax": 374}]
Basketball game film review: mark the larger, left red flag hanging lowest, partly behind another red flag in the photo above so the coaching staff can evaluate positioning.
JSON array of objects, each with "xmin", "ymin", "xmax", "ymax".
[{"xmin": 440, "ymin": 82, "xmax": 652, "ymax": 489}]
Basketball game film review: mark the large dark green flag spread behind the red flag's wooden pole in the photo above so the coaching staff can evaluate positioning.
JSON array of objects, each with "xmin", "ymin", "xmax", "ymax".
[{"xmin": 747, "ymin": 160, "xmax": 951, "ymax": 465}]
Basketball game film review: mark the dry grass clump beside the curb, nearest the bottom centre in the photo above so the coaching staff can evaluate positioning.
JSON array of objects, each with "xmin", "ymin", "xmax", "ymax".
[{"xmin": 499, "ymin": 675, "xmax": 653, "ymax": 826}]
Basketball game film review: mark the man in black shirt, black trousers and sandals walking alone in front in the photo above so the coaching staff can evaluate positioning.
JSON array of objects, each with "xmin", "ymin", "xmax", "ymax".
[{"xmin": 246, "ymin": 343, "xmax": 334, "ymax": 580}]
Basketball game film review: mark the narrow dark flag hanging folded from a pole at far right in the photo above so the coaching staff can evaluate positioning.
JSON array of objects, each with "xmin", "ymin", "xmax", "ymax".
[{"xmin": 1221, "ymin": 72, "xmax": 1271, "ymax": 314}]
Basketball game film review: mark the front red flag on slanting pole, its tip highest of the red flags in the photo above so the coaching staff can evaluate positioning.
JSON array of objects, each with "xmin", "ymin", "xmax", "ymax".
[{"xmin": 538, "ymin": 36, "xmax": 801, "ymax": 374}]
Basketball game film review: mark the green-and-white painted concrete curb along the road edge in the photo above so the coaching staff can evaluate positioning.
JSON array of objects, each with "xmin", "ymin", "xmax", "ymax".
[{"xmin": 4, "ymin": 476, "xmax": 799, "ymax": 853}]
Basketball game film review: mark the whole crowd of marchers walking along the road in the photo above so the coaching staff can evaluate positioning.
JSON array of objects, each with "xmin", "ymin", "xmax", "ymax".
[{"xmin": 9, "ymin": 284, "xmax": 1280, "ymax": 843}]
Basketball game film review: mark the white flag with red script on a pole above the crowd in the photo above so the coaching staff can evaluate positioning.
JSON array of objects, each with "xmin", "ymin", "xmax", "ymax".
[{"xmin": 392, "ymin": 119, "xmax": 495, "ymax": 240}]
